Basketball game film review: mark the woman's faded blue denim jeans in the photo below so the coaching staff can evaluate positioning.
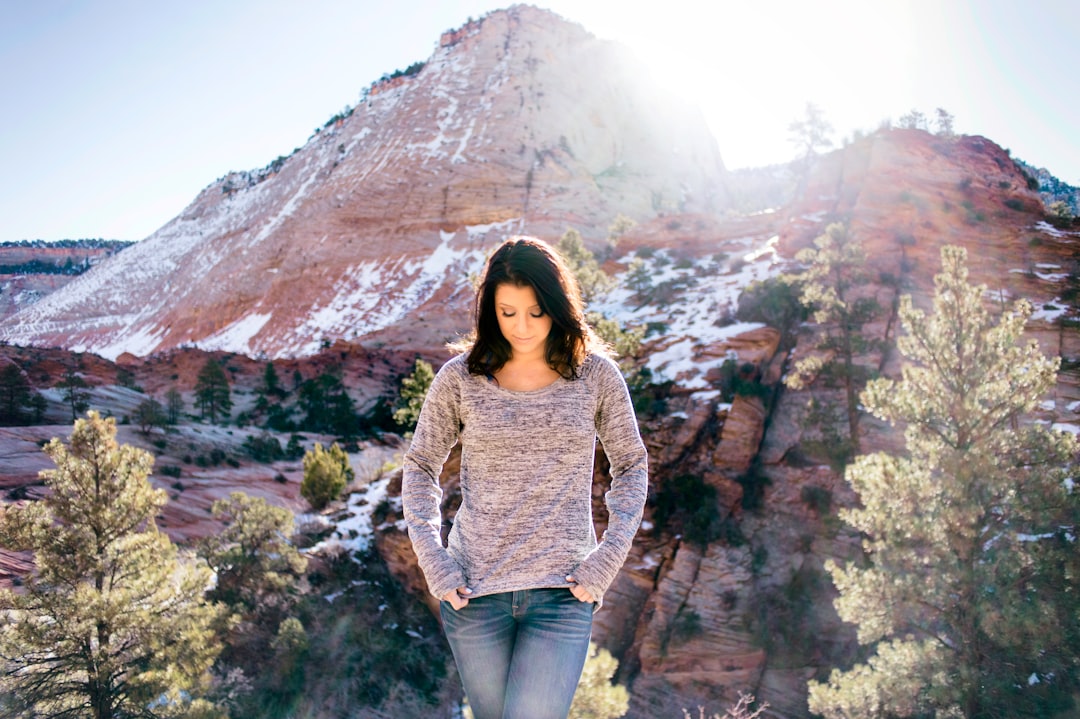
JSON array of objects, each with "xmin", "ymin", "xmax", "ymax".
[{"xmin": 440, "ymin": 588, "xmax": 594, "ymax": 719}]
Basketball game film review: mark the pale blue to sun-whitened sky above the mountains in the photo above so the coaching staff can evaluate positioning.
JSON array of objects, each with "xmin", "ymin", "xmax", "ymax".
[{"xmin": 0, "ymin": 0, "xmax": 1080, "ymax": 241}]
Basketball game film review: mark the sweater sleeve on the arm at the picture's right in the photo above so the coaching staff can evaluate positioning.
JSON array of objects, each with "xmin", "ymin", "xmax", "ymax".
[{"xmin": 573, "ymin": 358, "xmax": 649, "ymax": 598}]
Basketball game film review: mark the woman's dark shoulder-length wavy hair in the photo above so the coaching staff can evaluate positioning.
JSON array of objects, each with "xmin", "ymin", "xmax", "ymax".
[{"xmin": 465, "ymin": 235, "xmax": 602, "ymax": 379}]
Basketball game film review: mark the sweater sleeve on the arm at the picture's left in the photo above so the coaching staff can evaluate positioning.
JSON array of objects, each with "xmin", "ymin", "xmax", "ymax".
[{"xmin": 402, "ymin": 360, "xmax": 465, "ymax": 598}]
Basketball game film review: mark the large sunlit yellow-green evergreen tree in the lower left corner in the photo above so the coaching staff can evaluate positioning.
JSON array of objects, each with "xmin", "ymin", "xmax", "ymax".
[{"xmin": 0, "ymin": 412, "xmax": 220, "ymax": 719}]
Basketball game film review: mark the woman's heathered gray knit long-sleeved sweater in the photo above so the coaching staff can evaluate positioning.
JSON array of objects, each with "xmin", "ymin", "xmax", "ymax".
[{"xmin": 402, "ymin": 354, "xmax": 648, "ymax": 602}]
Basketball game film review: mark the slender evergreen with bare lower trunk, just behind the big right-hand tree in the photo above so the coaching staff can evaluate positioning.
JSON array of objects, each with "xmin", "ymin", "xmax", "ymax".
[{"xmin": 785, "ymin": 222, "xmax": 880, "ymax": 452}]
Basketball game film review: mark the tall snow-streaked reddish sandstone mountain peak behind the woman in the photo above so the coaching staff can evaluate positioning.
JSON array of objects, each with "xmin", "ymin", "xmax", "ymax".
[{"xmin": 0, "ymin": 5, "xmax": 726, "ymax": 357}]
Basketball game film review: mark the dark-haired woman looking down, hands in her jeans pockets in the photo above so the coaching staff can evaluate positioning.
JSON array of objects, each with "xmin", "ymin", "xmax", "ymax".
[{"xmin": 402, "ymin": 238, "xmax": 648, "ymax": 719}]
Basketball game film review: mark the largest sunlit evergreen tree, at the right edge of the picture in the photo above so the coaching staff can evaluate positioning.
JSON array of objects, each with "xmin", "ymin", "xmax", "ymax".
[{"xmin": 810, "ymin": 247, "xmax": 1080, "ymax": 719}]
